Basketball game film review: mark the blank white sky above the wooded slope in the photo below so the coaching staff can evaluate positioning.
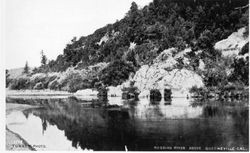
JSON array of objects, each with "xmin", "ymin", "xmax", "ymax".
[{"xmin": 4, "ymin": 0, "xmax": 152, "ymax": 69}]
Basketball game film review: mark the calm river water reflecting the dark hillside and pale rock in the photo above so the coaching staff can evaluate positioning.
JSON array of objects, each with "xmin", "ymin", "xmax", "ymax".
[{"xmin": 6, "ymin": 97, "xmax": 249, "ymax": 151}]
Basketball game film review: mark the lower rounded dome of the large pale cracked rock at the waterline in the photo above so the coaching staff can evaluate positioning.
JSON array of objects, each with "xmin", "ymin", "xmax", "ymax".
[{"xmin": 134, "ymin": 66, "xmax": 203, "ymax": 97}]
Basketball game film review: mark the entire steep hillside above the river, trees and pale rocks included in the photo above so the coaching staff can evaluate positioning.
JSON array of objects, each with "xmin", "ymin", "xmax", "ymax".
[{"xmin": 5, "ymin": 0, "xmax": 249, "ymax": 93}]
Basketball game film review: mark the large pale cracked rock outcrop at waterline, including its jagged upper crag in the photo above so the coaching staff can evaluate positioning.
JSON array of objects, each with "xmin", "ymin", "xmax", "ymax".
[{"xmin": 123, "ymin": 48, "xmax": 203, "ymax": 97}]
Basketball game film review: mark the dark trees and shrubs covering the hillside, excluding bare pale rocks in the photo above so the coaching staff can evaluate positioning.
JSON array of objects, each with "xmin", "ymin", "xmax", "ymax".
[{"xmin": 8, "ymin": 0, "xmax": 249, "ymax": 92}]
